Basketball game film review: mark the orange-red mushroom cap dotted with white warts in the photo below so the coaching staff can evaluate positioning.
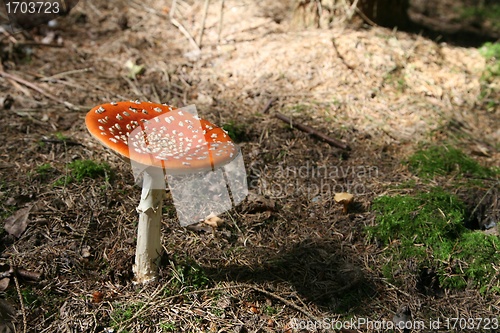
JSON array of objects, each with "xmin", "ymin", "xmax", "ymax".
[{"xmin": 85, "ymin": 101, "xmax": 238, "ymax": 173}]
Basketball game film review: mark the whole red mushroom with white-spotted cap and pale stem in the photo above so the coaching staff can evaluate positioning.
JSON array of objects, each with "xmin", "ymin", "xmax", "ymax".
[{"xmin": 85, "ymin": 101, "xmax": 246, "ymax": 282}]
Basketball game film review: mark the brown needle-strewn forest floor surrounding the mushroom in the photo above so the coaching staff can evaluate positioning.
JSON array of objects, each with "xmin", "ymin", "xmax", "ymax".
[{"xmin": 0, "ymin": 0, "xmax": 500, "ymax": 332}]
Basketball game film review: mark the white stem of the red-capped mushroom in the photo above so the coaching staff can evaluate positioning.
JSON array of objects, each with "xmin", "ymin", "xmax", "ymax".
[{"xmin": 133, "ymin": 168, "xmax": 165, "ymax": 283}]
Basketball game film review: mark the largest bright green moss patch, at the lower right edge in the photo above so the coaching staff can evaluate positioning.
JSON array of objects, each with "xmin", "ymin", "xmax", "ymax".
[{"xmin": 368, "ymin": 188, "xmax": 500, "ymax": 293}]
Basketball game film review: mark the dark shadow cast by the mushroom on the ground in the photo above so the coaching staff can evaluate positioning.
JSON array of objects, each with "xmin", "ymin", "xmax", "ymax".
[{"xmin": 204, "ymin": 240, "xmax": 375, "ymax": 311}]
